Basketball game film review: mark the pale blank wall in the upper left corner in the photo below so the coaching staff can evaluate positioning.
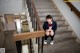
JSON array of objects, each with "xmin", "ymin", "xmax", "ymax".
[{"xmin": 0, "ymin": 0, "xmax": 24, "ymax": 14}]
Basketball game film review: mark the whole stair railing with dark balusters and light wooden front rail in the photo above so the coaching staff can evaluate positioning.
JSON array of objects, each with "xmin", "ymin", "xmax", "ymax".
[{"xmin": 14, "ymin": 0, "xmax": 45, "ymax": 53}]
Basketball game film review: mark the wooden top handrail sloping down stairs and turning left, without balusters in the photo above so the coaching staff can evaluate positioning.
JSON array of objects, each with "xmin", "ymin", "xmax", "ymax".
[{"xmin": 14, "ymin": 0, "xmax": 45, "ymax": 41}]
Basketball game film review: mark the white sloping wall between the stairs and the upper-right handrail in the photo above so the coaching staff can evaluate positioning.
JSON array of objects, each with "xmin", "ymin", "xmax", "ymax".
[{"xmin": 53, "ymin": 0, "xmax": 80, "ymax": 39}]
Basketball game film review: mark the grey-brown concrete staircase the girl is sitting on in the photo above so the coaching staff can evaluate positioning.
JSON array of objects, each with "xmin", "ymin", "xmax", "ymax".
[{"xmin": 34, "ymin": 0, "xmax": 80, "ymax": 53}]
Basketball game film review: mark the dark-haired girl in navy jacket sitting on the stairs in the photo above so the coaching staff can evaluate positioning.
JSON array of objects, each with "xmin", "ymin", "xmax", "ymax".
[{"xmin": 43, "ymin": 15, "xmax": 57, "ymax": 45}]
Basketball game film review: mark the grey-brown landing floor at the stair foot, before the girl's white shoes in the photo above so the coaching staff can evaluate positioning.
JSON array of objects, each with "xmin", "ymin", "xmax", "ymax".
[{"xmin": 43, "ymin": 39, "xmax": 80, "ymax": 53}]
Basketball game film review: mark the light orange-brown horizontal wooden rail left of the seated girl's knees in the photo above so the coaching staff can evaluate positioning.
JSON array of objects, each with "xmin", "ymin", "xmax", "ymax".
[{"xmin": 14, "ymin": 31, "xmax": 45, "ymax": 41}]
